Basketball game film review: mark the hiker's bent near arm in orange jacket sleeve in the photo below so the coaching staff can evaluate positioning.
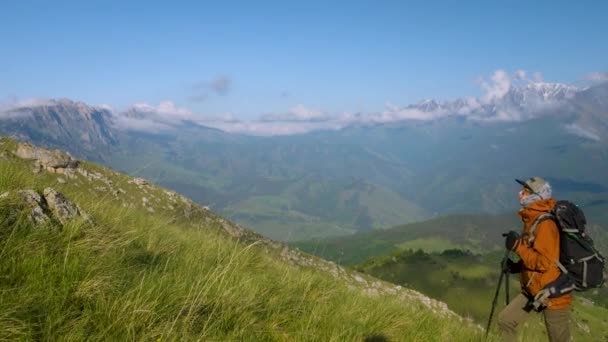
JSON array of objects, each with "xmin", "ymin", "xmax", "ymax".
[{"xmin": 517, "ymin": 220, "xmax": 559, "ymax": 272}]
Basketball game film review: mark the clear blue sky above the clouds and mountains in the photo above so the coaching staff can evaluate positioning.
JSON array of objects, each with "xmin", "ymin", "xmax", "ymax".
[{"xmin": 0, "ymin": 1, "xmax": 608, "ymax": 118}]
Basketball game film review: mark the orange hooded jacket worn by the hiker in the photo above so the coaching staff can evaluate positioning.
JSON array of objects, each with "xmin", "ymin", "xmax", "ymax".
[{"xmin": 515, "ymin": 198, "xmax": 572, "ymax": 310}]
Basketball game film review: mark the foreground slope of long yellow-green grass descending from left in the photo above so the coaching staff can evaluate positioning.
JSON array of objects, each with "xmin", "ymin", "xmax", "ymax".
[{"xmin": 0, "ymin": 139, "xmax": 481, "ymax": 341}]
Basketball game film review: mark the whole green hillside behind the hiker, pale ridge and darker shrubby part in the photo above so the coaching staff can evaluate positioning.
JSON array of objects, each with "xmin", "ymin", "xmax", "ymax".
[{"xmin": 294, "ymin": 214, "xmax": 608, "ymax": 340}]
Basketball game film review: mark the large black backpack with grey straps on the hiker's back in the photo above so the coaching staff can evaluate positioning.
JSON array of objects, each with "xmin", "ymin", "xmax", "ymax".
[{"xmin": 529, "ymin": 201, "xmax": 605, "ymax": 297}]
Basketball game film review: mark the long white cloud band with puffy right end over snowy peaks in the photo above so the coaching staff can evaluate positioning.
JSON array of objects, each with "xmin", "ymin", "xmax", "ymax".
[{"xmin": 197, "ymin": 70, "xmax": 576, "ymax": 135}]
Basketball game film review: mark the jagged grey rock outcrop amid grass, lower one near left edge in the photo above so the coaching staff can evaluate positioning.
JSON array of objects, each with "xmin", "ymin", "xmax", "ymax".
[{"xmin": 5, "ymin": 188, "xmax": 93, "ymax": 225}]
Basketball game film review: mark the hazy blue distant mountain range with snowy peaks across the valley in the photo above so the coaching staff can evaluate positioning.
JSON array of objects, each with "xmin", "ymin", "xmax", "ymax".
[{"xmin": 0, "ymin": 83, "xmax": 608, "ymax": 240}]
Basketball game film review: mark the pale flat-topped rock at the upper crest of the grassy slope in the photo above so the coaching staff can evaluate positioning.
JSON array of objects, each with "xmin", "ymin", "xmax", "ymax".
[{"xmin": 14, "ymin": 143, "xmax": 79, "ymax": 177}]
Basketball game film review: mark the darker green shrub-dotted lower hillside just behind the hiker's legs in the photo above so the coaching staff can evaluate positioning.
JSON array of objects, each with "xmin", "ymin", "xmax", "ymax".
[{"xmin": 355, "ymin": 250, "xmax": 608, "ymax": 341}]
